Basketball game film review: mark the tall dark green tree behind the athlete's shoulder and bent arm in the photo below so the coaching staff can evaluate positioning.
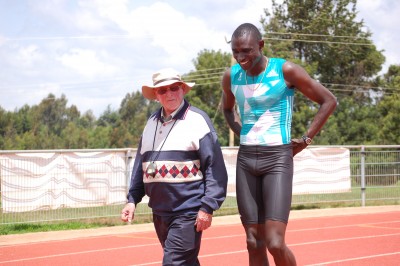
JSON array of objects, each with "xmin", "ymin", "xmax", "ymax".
[{"xmin": 261, "ymin": 0, "xmax": 384, "ymax": 144}]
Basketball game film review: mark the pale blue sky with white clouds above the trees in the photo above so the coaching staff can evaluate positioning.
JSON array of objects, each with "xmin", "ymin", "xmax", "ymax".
[{"xmin": 0, "ymin": 0, "xmax": 400, "ymax": 118}]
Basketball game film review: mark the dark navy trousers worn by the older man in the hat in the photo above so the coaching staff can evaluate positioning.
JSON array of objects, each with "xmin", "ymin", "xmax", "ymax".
[{"xmin": 153, "ymin": 214, "xmax": 202, "ymax": 266}]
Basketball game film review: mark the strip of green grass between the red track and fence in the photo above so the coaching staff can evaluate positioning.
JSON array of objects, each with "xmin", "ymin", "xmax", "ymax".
[{"xmin": 0, "ymin": 184, "xmax": 400, "ymax": 235}]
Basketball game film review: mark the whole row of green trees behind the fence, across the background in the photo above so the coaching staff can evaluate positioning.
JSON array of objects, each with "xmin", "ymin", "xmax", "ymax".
[{"xmin": 0, "ymin": 0, "xmax": 400, "ymax": 150}]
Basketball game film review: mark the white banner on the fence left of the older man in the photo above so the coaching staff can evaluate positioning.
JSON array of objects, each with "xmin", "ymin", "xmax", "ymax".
[{"xmin": 0, "ymin": 151, "xmax": 128, "ymax": 213}]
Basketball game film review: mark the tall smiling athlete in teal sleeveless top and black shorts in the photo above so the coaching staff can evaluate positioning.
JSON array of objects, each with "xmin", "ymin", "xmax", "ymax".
[{"xmin": 222, "ymin": 23, "xmax": 336, "ymax": 266}]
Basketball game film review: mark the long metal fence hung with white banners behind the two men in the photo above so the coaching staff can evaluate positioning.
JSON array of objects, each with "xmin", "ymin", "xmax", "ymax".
[{"xmin": 0, "ymin": 145, "xmax": 400, "ymax": 224}]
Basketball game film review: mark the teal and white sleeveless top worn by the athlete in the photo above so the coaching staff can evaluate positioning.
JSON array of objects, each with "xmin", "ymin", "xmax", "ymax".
[{"xmin": 231, "ymin": 58, "xmax": 294, "ymax": 146}]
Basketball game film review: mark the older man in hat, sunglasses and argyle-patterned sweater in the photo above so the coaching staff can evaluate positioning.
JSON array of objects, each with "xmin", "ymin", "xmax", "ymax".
[{"xmin": 121, "ymin": 69, "xmax": 228, "ymax": 265}]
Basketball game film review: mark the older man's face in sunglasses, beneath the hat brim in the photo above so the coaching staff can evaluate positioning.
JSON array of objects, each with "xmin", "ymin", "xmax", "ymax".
[{"xmin": 155, "ymin": 83, "xmax": 185, "ymax": 116}]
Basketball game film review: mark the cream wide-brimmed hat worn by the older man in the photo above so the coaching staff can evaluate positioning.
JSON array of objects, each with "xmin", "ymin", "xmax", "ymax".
[{"xmin": 142, "ymin": 68, "xmax": 195, "ymax": 100}]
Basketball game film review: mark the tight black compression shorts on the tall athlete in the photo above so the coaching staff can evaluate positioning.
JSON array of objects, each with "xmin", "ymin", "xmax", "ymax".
[{"xmin": 236, "ymin": 144, "xmax": 293, "ymax": 224}]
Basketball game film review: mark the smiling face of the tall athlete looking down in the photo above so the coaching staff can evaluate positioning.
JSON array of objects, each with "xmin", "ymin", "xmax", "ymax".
[{"xmin": 231, "ymin": 33, "xmax": 264, "ymax": 71}]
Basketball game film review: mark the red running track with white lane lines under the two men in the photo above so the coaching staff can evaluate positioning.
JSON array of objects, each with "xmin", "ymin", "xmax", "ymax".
[{"xmin": 0, "ymin": 207, "xmax": 400, "ymax": 266}]
